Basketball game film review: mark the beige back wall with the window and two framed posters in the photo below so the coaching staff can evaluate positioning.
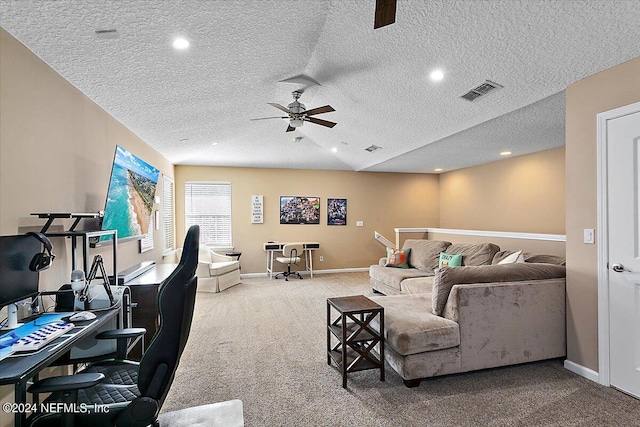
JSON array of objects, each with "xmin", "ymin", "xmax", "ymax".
[{"xmin": 176, "ymin": 166, "xmax": 439, "ymax": 273}]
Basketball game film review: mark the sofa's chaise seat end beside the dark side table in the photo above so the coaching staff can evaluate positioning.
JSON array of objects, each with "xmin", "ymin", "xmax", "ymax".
[{"xmin": 369, "ymin": 294, "xmax": 460, "ymax": 356}]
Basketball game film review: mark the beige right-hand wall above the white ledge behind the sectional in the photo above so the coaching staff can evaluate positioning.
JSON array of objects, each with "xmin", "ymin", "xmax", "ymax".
[{"xmin": 440, "ymin": 147, "xmax": 565, "ymax": 234}]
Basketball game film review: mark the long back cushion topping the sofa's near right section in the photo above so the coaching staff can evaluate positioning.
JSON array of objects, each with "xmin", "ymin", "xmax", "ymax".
[{"xmin": 431, "ymin": 262, "xmax": 566, "ymax": 316}]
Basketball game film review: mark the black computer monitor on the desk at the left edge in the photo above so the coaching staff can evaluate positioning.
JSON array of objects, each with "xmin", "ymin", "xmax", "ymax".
[{"xmin": 0, "ymin": 235, "xmax": 41, "ymax": 328}]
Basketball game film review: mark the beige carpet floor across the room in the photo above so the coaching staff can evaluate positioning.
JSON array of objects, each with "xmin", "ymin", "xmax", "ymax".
[{"xmin": 162, "ymin": 273, "xmax": 640, "ymax": 427}]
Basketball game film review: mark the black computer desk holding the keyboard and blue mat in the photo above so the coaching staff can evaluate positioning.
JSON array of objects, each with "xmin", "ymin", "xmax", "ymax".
[{"xmin": 0, "ymin": 308, "xmax": 120, "ymax": 427}]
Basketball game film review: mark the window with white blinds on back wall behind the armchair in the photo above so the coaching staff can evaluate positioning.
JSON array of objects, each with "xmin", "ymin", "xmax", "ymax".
[{"xmin": 184, "ymin": 182, "xmax": 233, "ymax": 248}]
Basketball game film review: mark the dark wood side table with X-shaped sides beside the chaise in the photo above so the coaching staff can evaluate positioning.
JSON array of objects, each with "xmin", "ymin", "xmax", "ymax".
[{"xmin": 327, "ymin": 295, "xmax": 384, "ymax": 388}]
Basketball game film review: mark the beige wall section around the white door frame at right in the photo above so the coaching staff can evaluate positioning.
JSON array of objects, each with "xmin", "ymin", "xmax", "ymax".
[{"xmin": 566, "ymin": 58, "xmax": 640, "ymax": 371}]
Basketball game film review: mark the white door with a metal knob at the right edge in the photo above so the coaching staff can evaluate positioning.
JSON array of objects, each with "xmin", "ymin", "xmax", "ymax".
[{"xmin": 607, "ymin": 108, "xmax": 640, "ymax": 398}]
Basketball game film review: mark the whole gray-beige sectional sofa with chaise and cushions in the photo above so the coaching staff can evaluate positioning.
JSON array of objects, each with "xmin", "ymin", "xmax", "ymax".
[{"xmin": 370, "ymin": 240, "xmax": 566, "ymax": 387}]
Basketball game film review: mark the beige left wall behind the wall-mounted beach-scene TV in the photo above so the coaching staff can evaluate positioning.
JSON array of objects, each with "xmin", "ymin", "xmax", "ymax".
[{"xmin": 0, "ymin": 29, "xmax": 173, "ymax": 426}]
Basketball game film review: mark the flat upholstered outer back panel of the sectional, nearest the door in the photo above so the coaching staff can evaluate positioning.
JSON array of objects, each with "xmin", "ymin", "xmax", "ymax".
[{"xmin": 443, "ymin": 278, "xmax": 566, "ymax": 370}]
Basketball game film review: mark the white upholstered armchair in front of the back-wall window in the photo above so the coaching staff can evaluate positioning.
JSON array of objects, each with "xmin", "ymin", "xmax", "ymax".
[{"xmin": 176, "ymin": 243, "xmax": 240, "ymax": 292}]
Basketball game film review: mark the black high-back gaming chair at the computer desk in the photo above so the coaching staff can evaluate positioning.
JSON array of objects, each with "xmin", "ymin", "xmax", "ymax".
[{"xmin": 28, "ymin": 226, "xmax": 200, "ymax": 427}]
